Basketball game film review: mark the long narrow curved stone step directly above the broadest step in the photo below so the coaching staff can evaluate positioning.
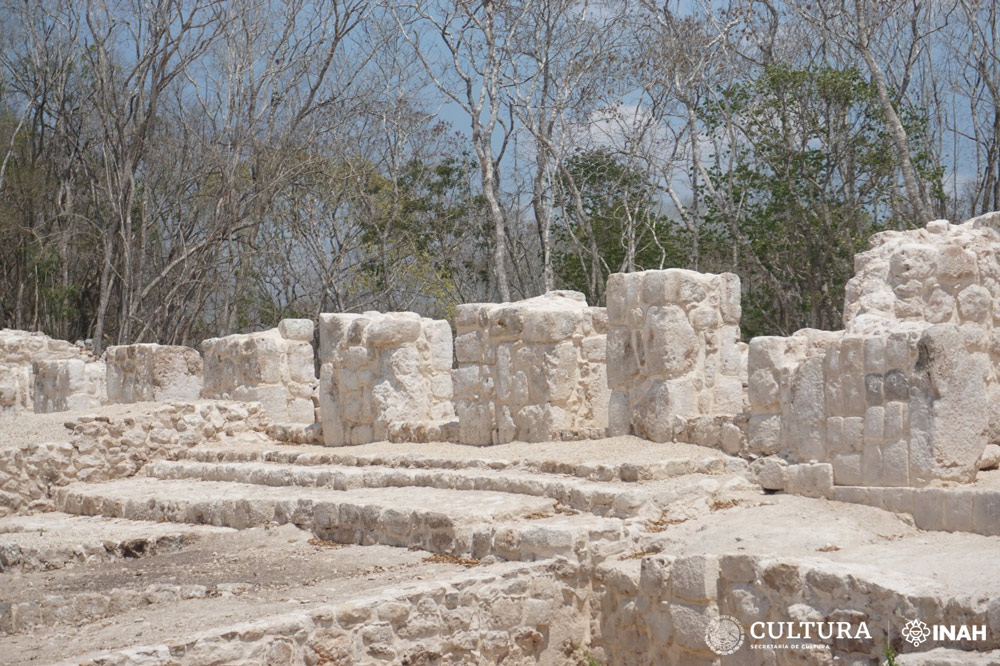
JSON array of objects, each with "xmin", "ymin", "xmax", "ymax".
[{"xmin": 144, "ymin": 460, "xmax": 659, "ymax": 518}]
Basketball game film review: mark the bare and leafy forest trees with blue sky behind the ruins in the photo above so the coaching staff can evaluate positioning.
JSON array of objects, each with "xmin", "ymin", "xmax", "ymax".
[{"xmin": 0, "ymin": 0, "xmax": 1000, "ymax": 350}]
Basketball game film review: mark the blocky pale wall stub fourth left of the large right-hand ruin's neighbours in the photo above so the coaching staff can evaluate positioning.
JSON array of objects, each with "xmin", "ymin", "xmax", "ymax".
[{"xmin": 319, "ymin": 312, "xmax": 457, "ymax": 446}]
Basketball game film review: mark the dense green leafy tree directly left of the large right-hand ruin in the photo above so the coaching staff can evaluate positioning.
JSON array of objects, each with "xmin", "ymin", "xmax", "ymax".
[{"xmin": 702, "ymin": 67, "xmax": 943, "ymax": 336}]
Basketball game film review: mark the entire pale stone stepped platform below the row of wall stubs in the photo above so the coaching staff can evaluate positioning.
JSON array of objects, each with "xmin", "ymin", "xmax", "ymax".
[{"xmin": 0, "ymin": 426, "xmax": 1000, "ymax": 666}]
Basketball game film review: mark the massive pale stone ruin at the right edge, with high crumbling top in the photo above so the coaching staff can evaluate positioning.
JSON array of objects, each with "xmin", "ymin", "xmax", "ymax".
[{"xmin": 745, "ymin": 214, "xmax": 1000, "ymax": 492}]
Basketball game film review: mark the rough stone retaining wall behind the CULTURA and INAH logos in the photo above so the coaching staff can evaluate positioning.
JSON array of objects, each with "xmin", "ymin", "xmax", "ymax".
[{"xmin": 590, "ymin": 554, "xmax": 1000, "ymax": 664}]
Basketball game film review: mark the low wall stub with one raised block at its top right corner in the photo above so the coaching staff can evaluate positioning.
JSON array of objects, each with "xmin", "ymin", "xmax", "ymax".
[{"xmin": 201, "ymin": 319, "xmax": 317, "ymax": 423}]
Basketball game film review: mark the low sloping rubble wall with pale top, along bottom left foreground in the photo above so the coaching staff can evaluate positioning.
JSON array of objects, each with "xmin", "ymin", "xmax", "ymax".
[{"xmin": 41, "ymin": 563, "xmax": 556, "ymax": 666}]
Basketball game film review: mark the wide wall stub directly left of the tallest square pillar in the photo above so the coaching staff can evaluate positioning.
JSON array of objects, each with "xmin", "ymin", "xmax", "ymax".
[{"xmin": 454, "ymin": 291, "xmax": 608, "ymax": 445}]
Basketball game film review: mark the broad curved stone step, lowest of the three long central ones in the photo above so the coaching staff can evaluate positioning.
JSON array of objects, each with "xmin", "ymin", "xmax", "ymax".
[{"xmin": 56, "ymin": 477, "xmax": 624, "ymax": 560}]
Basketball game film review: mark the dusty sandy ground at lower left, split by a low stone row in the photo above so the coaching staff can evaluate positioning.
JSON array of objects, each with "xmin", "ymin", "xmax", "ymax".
[{"xmin": 0, "ymin": 525, "xmax": 464, "ymax": 666}]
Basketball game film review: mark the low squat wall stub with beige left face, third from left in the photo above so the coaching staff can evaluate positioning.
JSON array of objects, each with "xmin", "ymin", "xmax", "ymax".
[{"xmin": 107, "ymin": 344, "xmax": 202, "ymax": 403}]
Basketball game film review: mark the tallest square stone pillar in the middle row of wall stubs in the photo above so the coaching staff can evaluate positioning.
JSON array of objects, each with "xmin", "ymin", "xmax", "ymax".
[{"xmin": 607, "ymin": 268, "xmax": 746, "ymax": 446}]
